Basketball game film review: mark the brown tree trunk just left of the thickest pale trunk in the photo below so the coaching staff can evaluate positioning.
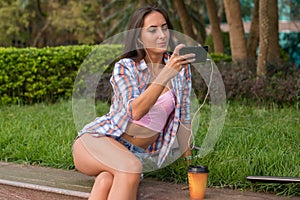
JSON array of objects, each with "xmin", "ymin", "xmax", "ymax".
[{"xmin": 205, "ymin": 0, "xmax": 224, "ymax": 53}]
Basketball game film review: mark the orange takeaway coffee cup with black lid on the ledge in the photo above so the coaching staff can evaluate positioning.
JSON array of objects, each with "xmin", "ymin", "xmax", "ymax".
[{"xmin": 188, "ymin": 165, "xmax": 209, "ymax": 200}]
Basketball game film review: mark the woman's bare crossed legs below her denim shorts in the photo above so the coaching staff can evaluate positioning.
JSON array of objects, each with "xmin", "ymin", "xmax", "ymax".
[{"xmin": 73, "ymin": 134, "xmax": 142, "ymax": 200}]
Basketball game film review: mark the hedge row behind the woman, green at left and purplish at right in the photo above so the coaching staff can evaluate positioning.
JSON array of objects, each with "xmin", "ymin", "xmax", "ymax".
[{"xmin": 0, "ymin": 45, "xmax": 300, "ymax": 105}]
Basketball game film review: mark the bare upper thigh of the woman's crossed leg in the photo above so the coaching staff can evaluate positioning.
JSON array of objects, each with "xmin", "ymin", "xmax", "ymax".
[{"xmin": 73, "ymin": 134, "xmax": 142, "ymax": 175}]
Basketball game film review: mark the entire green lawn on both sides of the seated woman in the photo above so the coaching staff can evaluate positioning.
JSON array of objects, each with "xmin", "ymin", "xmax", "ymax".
[{"xmin": 0, "ymin": 102, "xmax": 300, "ymax": 196}]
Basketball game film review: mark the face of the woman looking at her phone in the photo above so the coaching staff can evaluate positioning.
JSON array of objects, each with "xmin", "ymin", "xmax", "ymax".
[{"xmin": 141, "ymin": 11, "xmax": 170, "ymax": 54}]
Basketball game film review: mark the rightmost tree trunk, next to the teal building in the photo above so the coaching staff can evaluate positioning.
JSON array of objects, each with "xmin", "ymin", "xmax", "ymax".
[{"xmin": 267, "ymin": 0, "xmax": 280, "ymax": 64}]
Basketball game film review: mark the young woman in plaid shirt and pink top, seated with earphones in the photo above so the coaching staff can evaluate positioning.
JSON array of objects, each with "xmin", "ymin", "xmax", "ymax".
[{"xmin": 73, "ymin": 6, "xmax": 195, "ymax": 200}]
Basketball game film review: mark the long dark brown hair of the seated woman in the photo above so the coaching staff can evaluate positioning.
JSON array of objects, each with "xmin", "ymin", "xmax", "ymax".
[{"xmin": 121, "ymin": 5, "xmax": 175, "ymax": 61}]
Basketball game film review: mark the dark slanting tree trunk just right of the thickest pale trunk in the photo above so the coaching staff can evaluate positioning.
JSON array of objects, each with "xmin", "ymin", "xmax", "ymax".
[{"xmin": 247, "ymin": 0, "xmax": 259, "ymax": 59}]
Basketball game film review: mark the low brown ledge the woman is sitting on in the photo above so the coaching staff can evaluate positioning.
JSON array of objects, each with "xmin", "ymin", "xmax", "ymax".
[{"xmin": 0, "ymin": 162, "xmax": 300, "ymax": 200}]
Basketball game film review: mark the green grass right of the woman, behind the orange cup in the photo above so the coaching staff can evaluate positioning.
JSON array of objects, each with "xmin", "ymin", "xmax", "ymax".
[{"xmin": 150, "ymin": 103, "xmax": 300, "ymax": 196}]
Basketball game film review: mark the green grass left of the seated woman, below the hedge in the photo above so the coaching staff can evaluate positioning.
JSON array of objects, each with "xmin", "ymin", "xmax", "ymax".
[{"xmin": 0, "ymin": 102, "xmax": 77, "ymax": 169}]
